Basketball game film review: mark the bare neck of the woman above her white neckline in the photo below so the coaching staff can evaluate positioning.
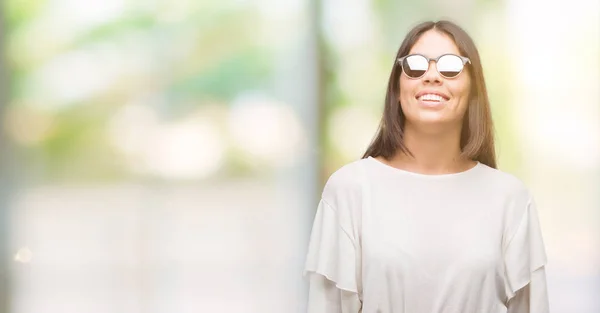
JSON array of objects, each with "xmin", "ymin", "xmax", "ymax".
[{"xmin": 393, "ymin": 123, "xmax": 473, "ymax": 174}]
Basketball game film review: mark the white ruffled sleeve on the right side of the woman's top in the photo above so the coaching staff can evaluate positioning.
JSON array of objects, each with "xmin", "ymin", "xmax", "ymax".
[{"xmin": 504, "ymin": 198, "xmax": 548, "ymax": 313}]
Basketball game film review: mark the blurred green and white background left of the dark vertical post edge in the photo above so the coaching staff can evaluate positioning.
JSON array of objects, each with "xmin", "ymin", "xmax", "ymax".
[{"xmin": 2, "ymin": 0, "xmax": 320, "ymax": 313}]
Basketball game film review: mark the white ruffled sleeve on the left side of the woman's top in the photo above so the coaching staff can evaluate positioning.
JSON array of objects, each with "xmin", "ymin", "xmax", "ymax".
[{"xmin": 304, "ymin": 200, "xmax": 361, "ymax": 313}]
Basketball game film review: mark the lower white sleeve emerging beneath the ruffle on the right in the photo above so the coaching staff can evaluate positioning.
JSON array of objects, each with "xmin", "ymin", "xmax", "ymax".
[{"xmin": 508, "ymin": 267, "xmax": 550, "ymax": 313}]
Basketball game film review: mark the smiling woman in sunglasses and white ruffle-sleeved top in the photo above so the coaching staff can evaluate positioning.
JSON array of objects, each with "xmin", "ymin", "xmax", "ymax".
[{"xmin": 305, "ymin": 21, "xmax": 548, "ymax": 313}]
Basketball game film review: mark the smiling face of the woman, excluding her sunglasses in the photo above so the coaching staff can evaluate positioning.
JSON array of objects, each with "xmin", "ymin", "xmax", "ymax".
[{"xmin": 400, "ymin": 30, "xmax": 471, "ymax": 127}]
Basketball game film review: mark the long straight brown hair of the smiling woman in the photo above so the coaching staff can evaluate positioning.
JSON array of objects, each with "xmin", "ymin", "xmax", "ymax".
[{"xmin": 363, "ymin": 21, "xmax": 496, "ymax": 168}]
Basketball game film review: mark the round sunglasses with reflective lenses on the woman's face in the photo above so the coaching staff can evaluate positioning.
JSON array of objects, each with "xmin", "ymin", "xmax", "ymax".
[{"xmin": 398, "ymin": 54, "xmax": 471, "ymax": 79}]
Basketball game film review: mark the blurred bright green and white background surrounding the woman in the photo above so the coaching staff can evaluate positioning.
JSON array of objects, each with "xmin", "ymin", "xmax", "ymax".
[{"xmin": 0, "ymin": 0, "xmax": 600, "ymax": 313}]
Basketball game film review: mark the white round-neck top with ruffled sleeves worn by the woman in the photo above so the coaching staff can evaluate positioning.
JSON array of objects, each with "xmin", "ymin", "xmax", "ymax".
[{"xmin": 305, "ymin": 157, "xmax": 548, "ymax": 313}]
